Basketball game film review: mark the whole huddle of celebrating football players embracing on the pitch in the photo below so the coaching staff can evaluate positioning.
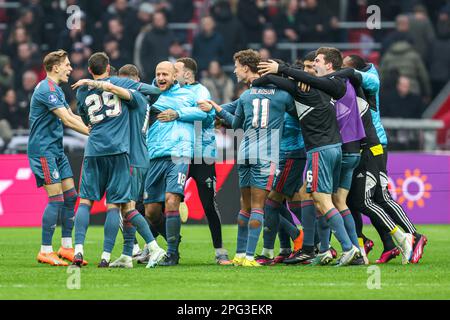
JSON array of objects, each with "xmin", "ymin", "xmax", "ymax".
[{"xmin": 28, "ymin": 47, "xmax": 427, "ymax": 268}]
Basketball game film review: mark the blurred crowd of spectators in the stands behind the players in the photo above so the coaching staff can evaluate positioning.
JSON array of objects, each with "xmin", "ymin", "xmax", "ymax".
[{"xmin": 0, "ymin": 0, "xmax": 450, "ymax": 146}]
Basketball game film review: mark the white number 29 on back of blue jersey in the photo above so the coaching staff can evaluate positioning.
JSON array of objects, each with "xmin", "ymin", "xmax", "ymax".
[{"xmin": 84, "ymin": 92, "xmax": 122, "ymax": 124}]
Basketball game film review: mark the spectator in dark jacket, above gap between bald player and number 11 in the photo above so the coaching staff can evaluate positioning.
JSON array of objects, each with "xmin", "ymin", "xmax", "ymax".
[{"xmin": 192, "ymin": 16, "xmax": 224, "ymax": 72}]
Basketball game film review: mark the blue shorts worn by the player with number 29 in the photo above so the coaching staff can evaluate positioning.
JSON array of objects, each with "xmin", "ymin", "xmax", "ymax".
[{"xmin": 80, "ymin": 153, "xmax": 131, "ymax": 204}]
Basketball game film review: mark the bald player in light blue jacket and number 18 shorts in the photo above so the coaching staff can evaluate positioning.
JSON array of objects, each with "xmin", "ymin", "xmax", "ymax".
[{"xmin": 144, "ymin": 61, "xmax": 207, "ymax": 266}]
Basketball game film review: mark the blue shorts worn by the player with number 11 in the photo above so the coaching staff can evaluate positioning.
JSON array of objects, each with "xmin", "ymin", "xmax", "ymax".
[{"xmin": 238, "ymin": 160, "xmax": 277, "ymax": 191}]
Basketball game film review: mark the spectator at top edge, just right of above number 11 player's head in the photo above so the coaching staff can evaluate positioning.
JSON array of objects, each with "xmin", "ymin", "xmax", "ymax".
[{"xmin": 274, "ymin": 0, "xmax": 300, "ymax": 42}]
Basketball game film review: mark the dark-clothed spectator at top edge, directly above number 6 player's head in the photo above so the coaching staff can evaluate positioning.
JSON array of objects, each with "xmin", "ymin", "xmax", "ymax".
[{"xmin": 298, "ymin": 0, "xmax": 337, "ymax": 42}]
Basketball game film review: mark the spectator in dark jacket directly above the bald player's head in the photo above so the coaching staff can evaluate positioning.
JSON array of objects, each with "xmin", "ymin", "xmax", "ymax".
[{"xmin": 139, "ymin": 11, "xmax": 175, "ymax": 81}]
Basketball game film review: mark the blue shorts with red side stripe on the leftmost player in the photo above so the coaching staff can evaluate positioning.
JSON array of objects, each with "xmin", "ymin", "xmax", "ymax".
[{"xmin": 28, "ymin": 154, "xmax": 73, "ymax": 188}]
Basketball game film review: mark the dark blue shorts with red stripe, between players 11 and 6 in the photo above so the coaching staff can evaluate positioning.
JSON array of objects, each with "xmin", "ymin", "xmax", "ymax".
[{"xmin": 273, "ymin": 158, "xmax": 306, "ymax": 197}]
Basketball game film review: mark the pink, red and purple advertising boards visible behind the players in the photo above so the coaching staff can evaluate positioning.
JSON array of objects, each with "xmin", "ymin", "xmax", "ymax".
[{"xmin": 0, "ymin": 152, "xmax": 450, "ymax": 227}]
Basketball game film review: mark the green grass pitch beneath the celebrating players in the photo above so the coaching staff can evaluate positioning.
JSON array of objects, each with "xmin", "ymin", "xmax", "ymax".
[{"xmin": 0, "ymin": 225, "xmax": 450, "ymax": 300}]
